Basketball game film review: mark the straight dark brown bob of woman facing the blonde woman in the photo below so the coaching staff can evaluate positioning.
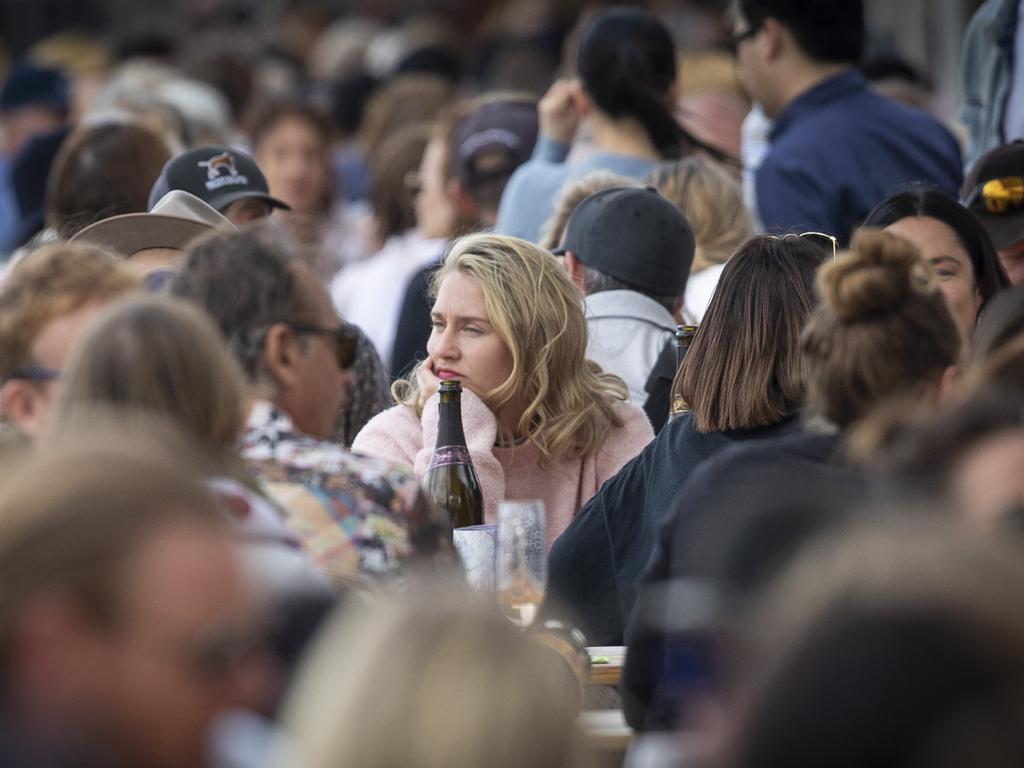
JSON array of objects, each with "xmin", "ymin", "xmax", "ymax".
[{"xmin": 673, "ymin": 237, "xmax": 821, "ymax": 432}]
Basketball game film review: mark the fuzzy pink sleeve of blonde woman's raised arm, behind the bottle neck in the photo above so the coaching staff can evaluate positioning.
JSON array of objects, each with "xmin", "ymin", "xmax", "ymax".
[{"xmin": 413, "ymin": 389, "xmax": 505, "ymax": 522}]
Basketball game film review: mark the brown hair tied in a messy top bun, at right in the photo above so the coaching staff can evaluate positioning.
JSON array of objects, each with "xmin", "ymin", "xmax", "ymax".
[{"xmin": 803, "ymin": 229, "xmax": 961, "ymax": 428}]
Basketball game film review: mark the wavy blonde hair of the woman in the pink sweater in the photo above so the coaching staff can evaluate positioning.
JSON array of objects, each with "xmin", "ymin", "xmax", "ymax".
[{"xmin": 391, "ymin": 233, "xmax": 628, "ymax": 467}]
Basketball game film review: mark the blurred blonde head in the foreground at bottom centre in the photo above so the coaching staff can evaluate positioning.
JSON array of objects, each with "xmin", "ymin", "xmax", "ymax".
[{"xmin": 280, "ymin": 585, "xmax": 584, "ymax": 768}]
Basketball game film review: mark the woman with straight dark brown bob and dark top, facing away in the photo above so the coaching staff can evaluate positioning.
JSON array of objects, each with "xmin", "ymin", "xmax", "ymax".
[{"xmin": 550, "ymin": 236, "xmax": 823, "ymax": 645}]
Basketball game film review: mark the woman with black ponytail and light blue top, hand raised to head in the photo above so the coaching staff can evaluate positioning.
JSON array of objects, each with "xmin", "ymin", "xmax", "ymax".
[{"xmin": 495, "ymin": 8, "xmax": 723, "ymax": 243}]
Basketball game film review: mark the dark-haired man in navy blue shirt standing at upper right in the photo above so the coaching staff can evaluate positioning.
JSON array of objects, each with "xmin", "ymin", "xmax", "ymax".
[{"xmin": 731, "ymin": 0, "xmax": 963, "ymax": 243}]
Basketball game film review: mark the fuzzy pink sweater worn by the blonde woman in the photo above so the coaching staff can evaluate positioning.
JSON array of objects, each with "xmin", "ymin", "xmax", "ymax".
[{"xmin": 352, "ymin": 389, "xmax": 654, "ymax": 547}]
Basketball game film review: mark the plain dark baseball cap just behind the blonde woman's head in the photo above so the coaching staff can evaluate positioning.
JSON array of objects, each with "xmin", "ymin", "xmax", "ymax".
[{"xmin": 555, "ymin": 186, "xmax": 695, "ymax": 296}]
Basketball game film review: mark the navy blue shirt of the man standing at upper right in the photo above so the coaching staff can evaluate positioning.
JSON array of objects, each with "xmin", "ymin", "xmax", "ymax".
[{"xmin": 755, "ymin": 70, "xmax": 963, "ymax": 244}]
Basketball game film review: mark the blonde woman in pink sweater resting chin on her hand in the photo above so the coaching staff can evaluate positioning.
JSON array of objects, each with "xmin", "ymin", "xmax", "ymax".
[{"xmin": 353, "ymin": 234, "xmax": 653, "ymax": 545}]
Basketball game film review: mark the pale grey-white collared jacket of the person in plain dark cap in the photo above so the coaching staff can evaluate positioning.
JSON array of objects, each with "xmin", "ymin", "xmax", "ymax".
[{"xmin": 584, "ymin": 291, "xmax": 676, "ymax": 407}]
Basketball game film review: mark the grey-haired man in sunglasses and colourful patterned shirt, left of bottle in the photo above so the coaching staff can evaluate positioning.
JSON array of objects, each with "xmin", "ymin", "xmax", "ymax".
[{"xmin": 170, "ymin": 227, "xmax": 451, "ymax": 589}]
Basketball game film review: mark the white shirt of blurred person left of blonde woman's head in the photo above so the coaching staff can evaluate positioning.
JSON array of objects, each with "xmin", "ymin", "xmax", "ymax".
[{"xmin": 331, "ymin": 229, "xmax": 446, "ymax": 369}]
